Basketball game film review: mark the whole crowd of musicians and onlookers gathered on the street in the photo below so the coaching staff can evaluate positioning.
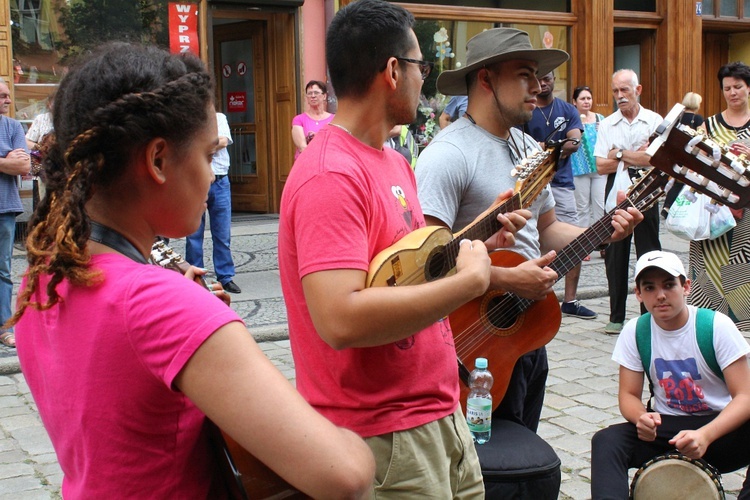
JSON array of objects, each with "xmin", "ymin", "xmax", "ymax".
[{"xmin": 0, "ymin": 0, "xmax": 750, "ymax": 499}]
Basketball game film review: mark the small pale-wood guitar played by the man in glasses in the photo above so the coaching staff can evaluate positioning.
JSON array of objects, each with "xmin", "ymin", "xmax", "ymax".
[{"xmin": 366, "ymin": 146, "xmax": 560, "ymax": 288}]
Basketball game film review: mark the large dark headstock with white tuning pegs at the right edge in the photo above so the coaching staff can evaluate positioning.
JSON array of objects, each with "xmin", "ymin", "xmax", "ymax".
[{"xmin": 646, "ymin": 104, "xmax": 750, "ymax": 208}]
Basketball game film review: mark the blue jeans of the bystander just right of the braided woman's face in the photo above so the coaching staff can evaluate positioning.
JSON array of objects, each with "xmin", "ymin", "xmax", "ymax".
[{"xmin": 185, "ymin": 176, "xmax": 235, "ymax": 285}]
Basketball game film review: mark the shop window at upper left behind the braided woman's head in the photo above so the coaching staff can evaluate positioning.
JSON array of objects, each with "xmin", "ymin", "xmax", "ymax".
[{"xmin": 10, "ymin": 0, "xmax": 198, "ymax": 126}]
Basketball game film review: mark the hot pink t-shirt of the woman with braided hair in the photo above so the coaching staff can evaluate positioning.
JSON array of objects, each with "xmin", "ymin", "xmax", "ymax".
[{"xmin": 16, "ymin": 254, "xmax": 241, "ymax": 499}]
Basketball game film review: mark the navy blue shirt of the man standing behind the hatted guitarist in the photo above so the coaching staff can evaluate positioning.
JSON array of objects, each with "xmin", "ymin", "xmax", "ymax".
[{"xmin": 519, "ymin": 98, "xmax": 583, "ymax": 189}]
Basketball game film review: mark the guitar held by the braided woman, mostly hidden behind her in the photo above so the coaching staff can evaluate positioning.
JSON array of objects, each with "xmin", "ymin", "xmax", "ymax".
[{"xmin": 150, "ymin": 241, "xmax": 310, "ymax": 500}]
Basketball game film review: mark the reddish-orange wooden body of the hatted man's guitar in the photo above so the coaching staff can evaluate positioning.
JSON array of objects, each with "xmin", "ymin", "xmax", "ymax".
[{"xmin": 449, "ymin": 250, "xmax": 562, "ymax": 411}]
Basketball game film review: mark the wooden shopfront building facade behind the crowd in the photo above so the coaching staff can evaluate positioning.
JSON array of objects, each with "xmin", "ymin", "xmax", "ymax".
[{"xmin": 0, "ymin": 0, "xmax": 750, "ymax": 212}]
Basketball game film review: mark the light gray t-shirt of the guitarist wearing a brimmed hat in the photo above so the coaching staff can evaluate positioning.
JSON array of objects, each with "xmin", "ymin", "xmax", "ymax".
[{"xmin": 415, "ymin": 117, "xmax": 555, "ymax": 259}]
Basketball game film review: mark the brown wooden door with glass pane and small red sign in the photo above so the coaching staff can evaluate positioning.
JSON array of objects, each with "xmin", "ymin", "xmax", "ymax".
[{"xmin": 213, "ymin": 21, "xmax": 270, "ymax": 213}]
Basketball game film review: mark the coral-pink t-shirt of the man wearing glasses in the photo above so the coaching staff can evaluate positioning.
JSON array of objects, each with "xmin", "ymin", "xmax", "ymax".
[{"xmin": 279, "ymin": 127, "xmax": 458, "ymax": 437}]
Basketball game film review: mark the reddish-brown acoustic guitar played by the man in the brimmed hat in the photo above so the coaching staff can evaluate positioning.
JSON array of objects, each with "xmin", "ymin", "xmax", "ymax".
[{"xmin": 450, "ymin": 104, "xmax": 750, "ymax": 410}]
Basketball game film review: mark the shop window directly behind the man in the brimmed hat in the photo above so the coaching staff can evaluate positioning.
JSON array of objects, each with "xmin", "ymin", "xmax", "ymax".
[{"xmin": 410, "ymin": 19, "xmax": 576, "ymax": 146}]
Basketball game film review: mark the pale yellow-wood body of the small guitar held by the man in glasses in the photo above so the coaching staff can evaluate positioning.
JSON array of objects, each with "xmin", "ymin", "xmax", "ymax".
[{"xmin": 366, "ymin": 226, "xmax": 453, "ymax": 288}]
